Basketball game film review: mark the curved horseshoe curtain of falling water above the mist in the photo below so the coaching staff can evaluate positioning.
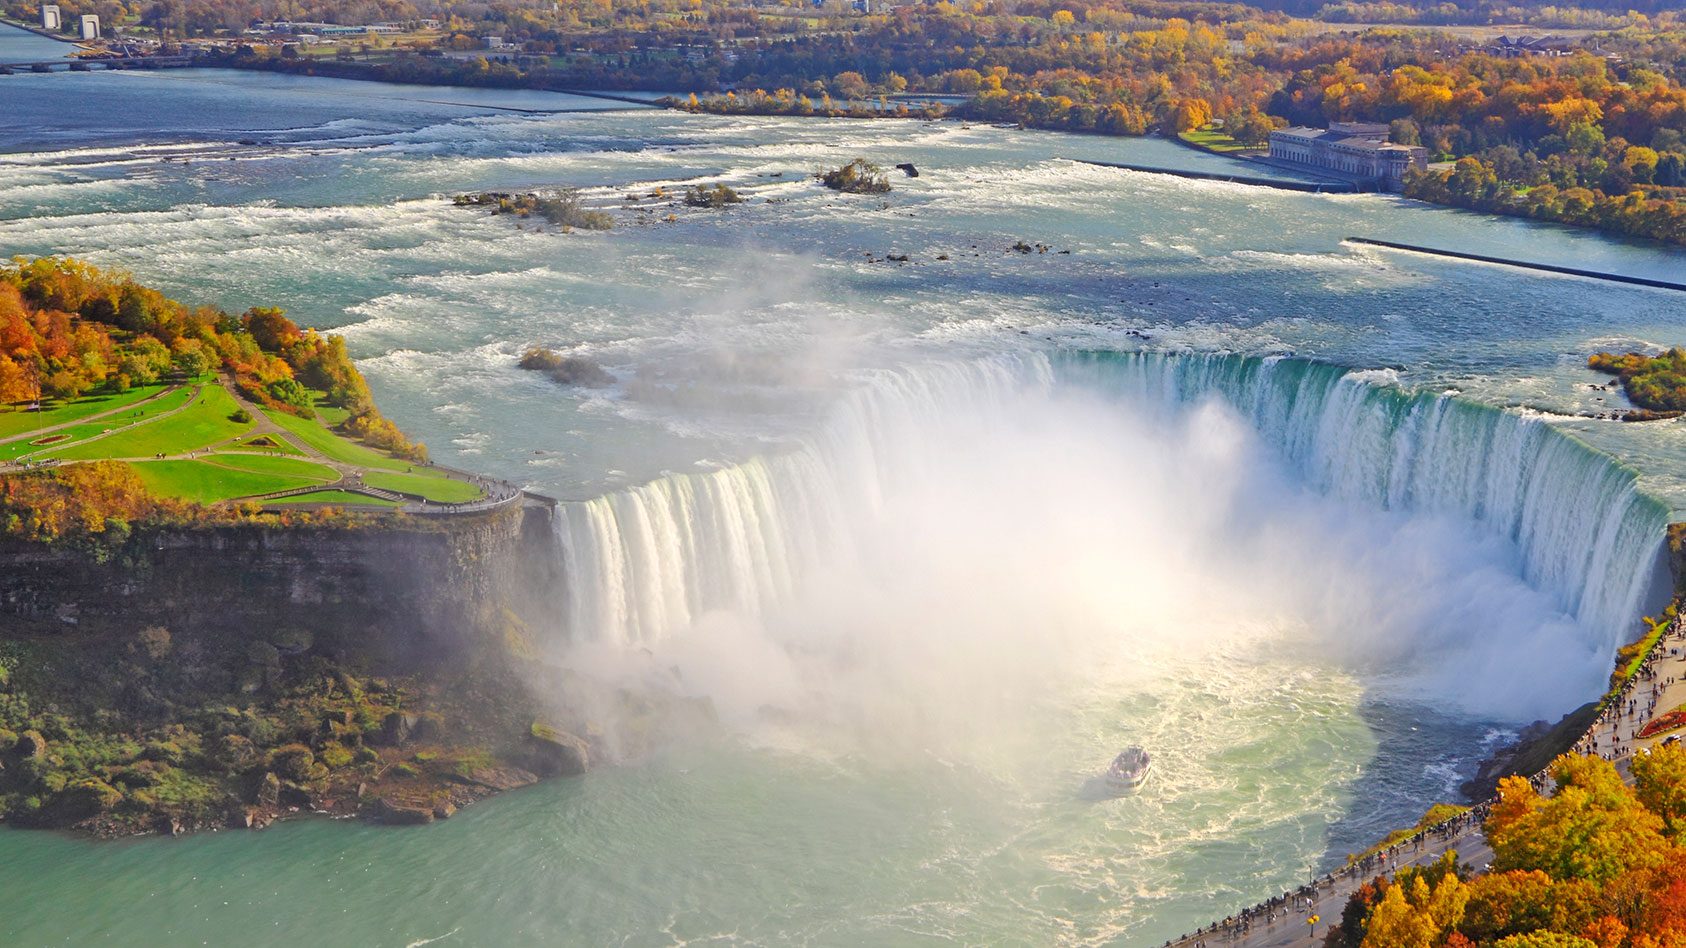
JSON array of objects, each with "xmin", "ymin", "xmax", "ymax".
[{"xmin": 556, "ymin": 353, "xmax": 1667, "ymax": 649}]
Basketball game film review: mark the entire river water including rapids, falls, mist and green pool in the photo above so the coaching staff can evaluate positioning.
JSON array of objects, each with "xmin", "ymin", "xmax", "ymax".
[{"xmin": 0, "ymin": 71, "xmax": 1686, "ymax": 945}]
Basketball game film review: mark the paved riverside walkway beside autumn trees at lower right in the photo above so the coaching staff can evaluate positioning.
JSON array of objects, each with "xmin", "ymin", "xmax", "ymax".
[{"xmin": 1167, "ymin": 619, "xmax": 1686, "ymax": 948}]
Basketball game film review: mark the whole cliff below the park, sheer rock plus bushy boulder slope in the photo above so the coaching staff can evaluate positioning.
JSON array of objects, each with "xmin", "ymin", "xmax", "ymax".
[{"xmin": 0, "ymin": 503, "xmax": 590, "ymax": 835}]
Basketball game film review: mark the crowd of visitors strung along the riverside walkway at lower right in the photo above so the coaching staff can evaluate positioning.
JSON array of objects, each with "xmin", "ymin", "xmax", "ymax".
[{"xmin": 1165, "ymin": 607, "xmax": 1686, "ymax": 948}]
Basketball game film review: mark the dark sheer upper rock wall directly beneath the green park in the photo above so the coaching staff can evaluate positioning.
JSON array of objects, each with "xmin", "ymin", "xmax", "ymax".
[{"xmin": 0, "ymin": 504, "xmax": 560, "ymax": 671}]
